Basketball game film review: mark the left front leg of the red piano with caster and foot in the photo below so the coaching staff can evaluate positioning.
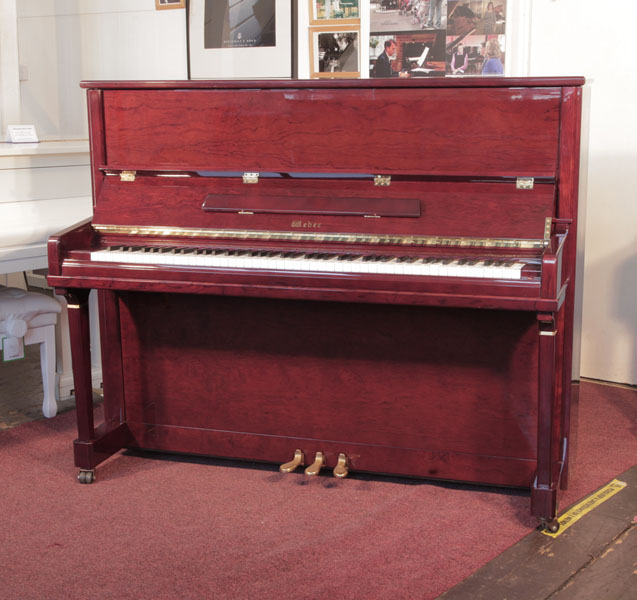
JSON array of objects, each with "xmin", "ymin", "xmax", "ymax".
[{"xmin": 64, "ymin": 290, "xmax": 130, "ymax": 483}]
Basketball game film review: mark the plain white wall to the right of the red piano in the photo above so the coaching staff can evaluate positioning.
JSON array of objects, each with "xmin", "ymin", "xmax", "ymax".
[{"xmin": 529, "ymin": 0, "xmax": 637, "ymax": 384}]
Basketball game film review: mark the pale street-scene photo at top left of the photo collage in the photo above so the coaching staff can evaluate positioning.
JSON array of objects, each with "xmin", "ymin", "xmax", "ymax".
[{"xmin": 369, "ymin": 0, "xmax": 447, "ymax": 33}]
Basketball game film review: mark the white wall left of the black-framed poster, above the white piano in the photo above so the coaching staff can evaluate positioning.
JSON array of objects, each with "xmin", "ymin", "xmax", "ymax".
[{"xmin": 16, "ymin": 0, "xmax": 187, "ymax": 139}]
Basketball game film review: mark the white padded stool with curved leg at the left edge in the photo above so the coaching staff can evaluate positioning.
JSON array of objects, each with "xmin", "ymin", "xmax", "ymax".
[{"xmin": 0, "ymin": 286, "xmax": 62, "ymax": 417}]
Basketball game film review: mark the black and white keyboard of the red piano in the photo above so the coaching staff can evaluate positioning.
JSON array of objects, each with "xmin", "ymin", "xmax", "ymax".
[{"xmin": 91, "ymin": 246, "xmax": 524, "ymax": 279}]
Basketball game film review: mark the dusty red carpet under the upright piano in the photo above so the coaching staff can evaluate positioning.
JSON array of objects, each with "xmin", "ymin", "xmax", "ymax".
[{"xmin": 0, "ymin": 383, "xmax": 637, "ymax": 600}]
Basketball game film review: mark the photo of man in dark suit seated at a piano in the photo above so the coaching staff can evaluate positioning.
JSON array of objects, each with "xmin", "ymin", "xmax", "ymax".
[{"xmin": 369, "ymin": 31, "xmax": 445, "ymax": 78}]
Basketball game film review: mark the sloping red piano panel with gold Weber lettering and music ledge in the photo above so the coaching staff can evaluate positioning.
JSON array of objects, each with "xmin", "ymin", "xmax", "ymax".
[{"xmin": 93, "ymin": 176, "xmax": 555, "ymax": 240}]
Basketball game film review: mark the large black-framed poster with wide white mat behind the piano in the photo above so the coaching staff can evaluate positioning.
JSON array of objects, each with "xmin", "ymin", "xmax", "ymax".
[{"xmin": 188, "ymin": 0, "xmax": 292, "ymax": 79}]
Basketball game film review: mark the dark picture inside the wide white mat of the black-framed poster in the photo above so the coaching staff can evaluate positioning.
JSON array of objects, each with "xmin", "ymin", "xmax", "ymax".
[{"xmin": 204, "ymin": 0, "xmax": 276, "ymax": 48}]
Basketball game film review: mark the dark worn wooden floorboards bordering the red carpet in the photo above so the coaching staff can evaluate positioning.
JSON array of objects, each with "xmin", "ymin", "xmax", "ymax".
[{"xmin": 0, "ymin": 346, "xmax": 637, "ymax": 600}]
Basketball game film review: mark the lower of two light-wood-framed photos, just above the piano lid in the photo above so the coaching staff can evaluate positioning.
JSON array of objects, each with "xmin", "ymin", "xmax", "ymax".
[{"xmin": 310, "ymin": 27, "xmax": 360, "ymax": 77}]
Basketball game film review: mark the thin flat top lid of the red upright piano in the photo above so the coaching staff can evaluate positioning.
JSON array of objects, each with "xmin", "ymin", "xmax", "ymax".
[{"xmin": 80, "ymin": 76, "xmax": 586, "ymax": 90}]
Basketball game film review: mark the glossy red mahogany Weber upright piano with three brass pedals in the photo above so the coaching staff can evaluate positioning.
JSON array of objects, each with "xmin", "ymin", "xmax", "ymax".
[{"xmin": 48, "ymin": 78, "xmax": 584, "ymax": 529}]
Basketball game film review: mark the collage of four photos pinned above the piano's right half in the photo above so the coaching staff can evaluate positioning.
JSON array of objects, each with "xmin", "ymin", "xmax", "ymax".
[{"xmin": 369, "ymin": 0, "xmax": 506, "ymax": 78}]
